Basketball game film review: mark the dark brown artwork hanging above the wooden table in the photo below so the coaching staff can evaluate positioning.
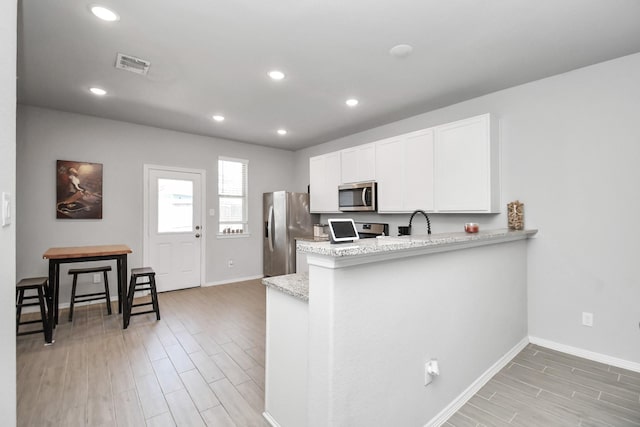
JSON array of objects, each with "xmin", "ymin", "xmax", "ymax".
[{"xmin": 56, "ymin": 160, "xmax": 102, "ymax": 219}]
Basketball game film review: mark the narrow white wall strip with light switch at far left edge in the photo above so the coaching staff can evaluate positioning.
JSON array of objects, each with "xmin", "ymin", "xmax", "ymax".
[{"xmin": 0, "ymin": 1, "xmax": 17, "ymax": 426}]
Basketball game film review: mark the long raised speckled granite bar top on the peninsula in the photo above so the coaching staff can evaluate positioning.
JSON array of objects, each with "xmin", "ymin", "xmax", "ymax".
[{"xmin": 296, "ymin": 228, "xmax": 538, "ymax": 258}]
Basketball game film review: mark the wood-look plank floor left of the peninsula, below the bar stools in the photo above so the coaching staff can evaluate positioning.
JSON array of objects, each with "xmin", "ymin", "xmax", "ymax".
[{"xmin": 17, "ymin": 280, "xmax": 268, "ymax": 427}]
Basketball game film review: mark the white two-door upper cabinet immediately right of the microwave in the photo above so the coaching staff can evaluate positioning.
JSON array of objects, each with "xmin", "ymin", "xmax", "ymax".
[{"xmin": 376, "ymin": 129, "xmax": 434, "ymax": 213}]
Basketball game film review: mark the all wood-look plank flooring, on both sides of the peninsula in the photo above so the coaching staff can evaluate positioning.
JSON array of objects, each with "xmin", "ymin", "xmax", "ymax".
[{"xmin": 17, "ymin": 280, "xmax": 640, "ymax": 427}]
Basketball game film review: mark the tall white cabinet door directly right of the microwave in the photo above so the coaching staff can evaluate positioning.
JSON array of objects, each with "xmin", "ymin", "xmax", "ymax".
[{"xmin": 375, "ymin": 138, "xmax": 404, "ymax": 213}]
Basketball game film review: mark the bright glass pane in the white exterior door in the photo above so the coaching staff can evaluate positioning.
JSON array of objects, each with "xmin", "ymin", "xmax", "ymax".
[{"xmin": 158, "ymin": 178, "xmax": 193, "ymax": 233}]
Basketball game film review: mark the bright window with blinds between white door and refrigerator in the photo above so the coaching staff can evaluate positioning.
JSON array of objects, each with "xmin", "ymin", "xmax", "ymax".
[{"xmin": 218, "ymin": 157, "xmax": 249, "ymax": 235}]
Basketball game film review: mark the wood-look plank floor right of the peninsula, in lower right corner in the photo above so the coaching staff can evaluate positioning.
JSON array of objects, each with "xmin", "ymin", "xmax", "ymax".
[{"xmin": 444, "ymin": 344, "xmax": 640, "ymax": 427}]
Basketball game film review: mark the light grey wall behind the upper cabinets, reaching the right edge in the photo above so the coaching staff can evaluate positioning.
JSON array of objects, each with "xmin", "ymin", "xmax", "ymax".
[{"xmin": 294, "ymin": 54, "xmax": 640, "ymax": 363}]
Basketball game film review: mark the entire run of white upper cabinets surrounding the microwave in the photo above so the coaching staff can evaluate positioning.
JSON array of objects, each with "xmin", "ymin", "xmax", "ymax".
[{"xmin": 309, "ymin": 114, "xmax": 500, "ymax": 213}]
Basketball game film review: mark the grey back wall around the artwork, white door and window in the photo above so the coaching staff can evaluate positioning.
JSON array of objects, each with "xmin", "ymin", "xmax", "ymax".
[{"xmin": 17, "ymin": 106, "xmax": 293, "ymax": 303}]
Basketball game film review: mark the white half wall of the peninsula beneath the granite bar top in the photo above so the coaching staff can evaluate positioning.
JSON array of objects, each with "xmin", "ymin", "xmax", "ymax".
[{"xmin": 308, "ymin": 240, "xmax": 530, "ymax": 427}]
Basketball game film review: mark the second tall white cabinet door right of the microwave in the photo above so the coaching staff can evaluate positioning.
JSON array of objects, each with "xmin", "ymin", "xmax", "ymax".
[{"xmin": 402, "ymin": 128, "xmax": 434, "ymax": 212}]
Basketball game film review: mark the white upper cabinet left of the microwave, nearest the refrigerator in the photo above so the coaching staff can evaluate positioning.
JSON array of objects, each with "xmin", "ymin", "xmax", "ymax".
[{"xmin": 309, "ymin": 151, "xmax": 340, "ymax": 213}]
